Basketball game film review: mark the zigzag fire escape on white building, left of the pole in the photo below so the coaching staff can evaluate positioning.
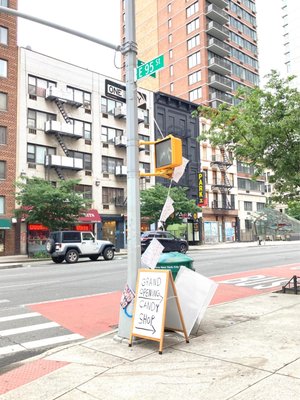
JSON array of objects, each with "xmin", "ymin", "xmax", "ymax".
[{"xmin": 45, "ymin": 86, "xmax": 83, "ymax": 180}]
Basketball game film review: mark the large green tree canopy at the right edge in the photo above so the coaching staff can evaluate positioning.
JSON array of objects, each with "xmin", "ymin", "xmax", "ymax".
[{"xmin": 194, "ymin": 71, "xmax": 300, "ymax": 202}]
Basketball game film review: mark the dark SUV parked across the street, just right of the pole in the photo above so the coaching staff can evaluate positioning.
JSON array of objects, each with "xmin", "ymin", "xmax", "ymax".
[{"xmin": 141, "ymin": 231, "xmax": 189, "ymax": 253}]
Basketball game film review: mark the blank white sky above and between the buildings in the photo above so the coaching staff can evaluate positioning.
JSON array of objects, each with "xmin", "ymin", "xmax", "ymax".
[{"xmin": 18, "ymin": 0, "xmax": 284, "ymax": 81}]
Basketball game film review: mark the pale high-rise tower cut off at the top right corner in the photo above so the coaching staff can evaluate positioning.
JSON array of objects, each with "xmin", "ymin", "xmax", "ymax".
[{"xmin": 282, "ymin": 0, "xmax": 300, "ymax": 88}]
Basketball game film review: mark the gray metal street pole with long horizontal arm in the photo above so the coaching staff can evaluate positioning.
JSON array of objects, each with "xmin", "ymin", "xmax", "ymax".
[{"xmin": 0, "ymin": 0, "xmax": 141, "ymax": 339}]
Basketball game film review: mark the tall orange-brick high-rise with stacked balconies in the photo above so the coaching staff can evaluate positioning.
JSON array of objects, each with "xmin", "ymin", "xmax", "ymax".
[{"xmin": 130, "ymin": 0, "xmax": 258, "ymax": 108}]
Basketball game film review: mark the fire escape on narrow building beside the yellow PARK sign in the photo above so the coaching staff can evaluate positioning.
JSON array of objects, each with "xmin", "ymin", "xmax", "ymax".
[{"xmin": 210, "ymin": 147, "xmax": 235, "ymax": 210}]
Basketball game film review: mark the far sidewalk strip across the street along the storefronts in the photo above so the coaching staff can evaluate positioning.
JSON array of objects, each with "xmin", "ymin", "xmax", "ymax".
[{"xmin": 0, "ymin": 241, "xmax": 300, "ymax": 269}]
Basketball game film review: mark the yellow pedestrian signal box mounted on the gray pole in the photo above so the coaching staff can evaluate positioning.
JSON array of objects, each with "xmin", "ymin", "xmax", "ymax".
[{"xmin": 154, "ymin": 135, "xmax": 182, "ymax": 174}]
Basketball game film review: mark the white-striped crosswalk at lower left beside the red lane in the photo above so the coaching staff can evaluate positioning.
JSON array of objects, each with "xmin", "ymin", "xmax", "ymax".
[{"xmin": 0, "ymin": 306, "xmax": 84, "ymax": 361}]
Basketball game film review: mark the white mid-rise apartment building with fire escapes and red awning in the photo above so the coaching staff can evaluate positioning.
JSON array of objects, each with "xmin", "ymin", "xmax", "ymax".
[{"xmin": 17, "ymin": 48, "xmax": 153, "ymax": 253}]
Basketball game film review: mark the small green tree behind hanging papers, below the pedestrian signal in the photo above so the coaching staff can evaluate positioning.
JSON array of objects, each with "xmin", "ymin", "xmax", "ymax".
[{"xmin": 141, "ymin": 184, "xmax": 201, "ymax": 225}]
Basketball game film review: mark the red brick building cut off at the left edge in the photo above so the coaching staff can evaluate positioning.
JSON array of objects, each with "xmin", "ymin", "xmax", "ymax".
[{"xmin": 0, "ymin": 0, "xmax": 19, "ymax": 256}]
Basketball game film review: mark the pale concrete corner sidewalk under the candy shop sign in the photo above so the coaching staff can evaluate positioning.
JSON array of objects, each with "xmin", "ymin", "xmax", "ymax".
[{"xmin": 0, "ymin": 293, "xmax": 300, "ymax": 400}]
